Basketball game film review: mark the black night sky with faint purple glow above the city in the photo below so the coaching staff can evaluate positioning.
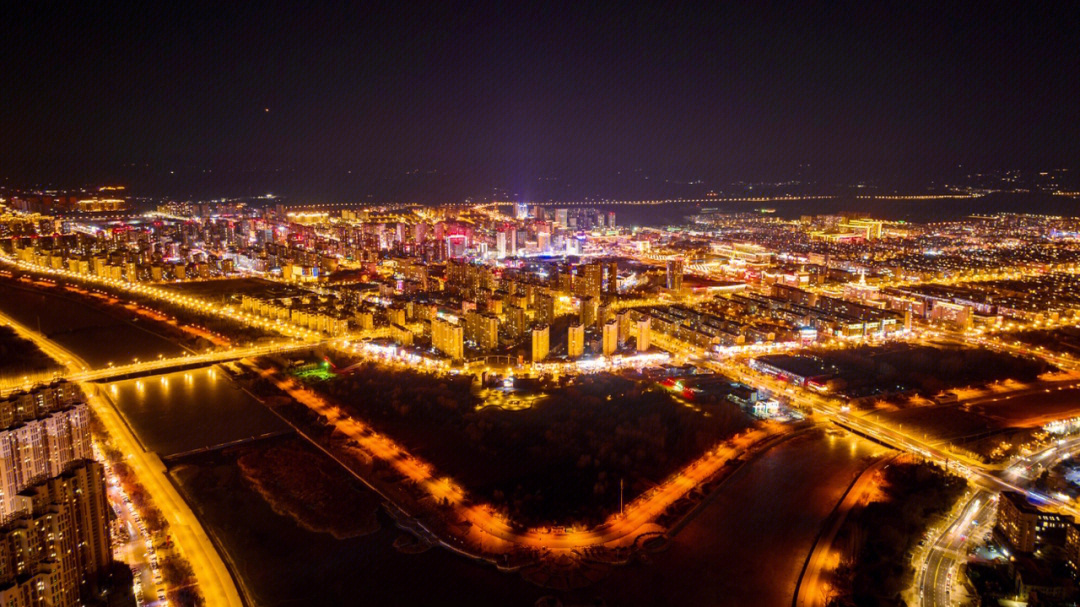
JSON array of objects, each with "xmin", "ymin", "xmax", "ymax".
[{"xmin": 0, "ymin": 2, "xmax": 1080, "ymax": 195}]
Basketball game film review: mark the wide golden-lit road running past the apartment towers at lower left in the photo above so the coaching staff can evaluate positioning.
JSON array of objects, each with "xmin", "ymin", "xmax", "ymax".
[{"xmin": 0, "ymin": 313, "xmax": 243, "ymax": 607}]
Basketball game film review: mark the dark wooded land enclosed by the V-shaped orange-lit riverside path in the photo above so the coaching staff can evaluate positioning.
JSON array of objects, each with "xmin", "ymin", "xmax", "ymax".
[{"xmin": 311, "ymin": 364, "xmax": 751, "ymax": 525}]
